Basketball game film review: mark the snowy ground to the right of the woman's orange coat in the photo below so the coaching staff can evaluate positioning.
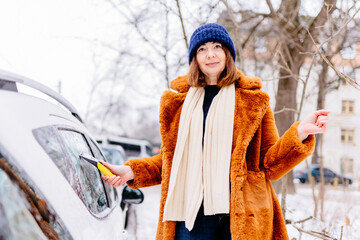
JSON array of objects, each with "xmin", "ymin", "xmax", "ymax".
[{"xmin": 286, "ymin": 184, "xmax": 360, "ymax": 240}]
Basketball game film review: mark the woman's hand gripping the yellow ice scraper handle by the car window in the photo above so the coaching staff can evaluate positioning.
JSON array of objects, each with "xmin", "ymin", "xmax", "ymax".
[{"xmin": 101, "ymin": 161, "xmax": 134, "ymax": 187}]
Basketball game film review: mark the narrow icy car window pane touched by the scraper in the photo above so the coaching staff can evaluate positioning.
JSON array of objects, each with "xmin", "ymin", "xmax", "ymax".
[{"xmin": 59, "ymin": 129, "xmax": 109, "ymax": 214}]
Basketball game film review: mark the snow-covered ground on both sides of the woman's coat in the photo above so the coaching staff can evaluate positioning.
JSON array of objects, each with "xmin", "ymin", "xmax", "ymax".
[{"xmin": 129, "ymin": 184, "xmax": 360, "ymax": 240}]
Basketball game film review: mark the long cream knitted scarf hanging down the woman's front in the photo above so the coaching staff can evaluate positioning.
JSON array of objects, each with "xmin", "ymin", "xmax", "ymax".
[{"xmin": 163, "ymin": 84, "xmax": 235, "ymax": 230}]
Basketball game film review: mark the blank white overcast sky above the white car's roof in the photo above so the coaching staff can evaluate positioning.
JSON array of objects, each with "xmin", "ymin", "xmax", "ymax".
[{"xmin": 0, "ymin": 0, "xmax": 119, "ymax": 114}]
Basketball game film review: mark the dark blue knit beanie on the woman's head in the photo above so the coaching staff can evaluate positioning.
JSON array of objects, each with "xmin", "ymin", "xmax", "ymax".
[{"xmin": 189, "ymin": 23, "xmax": 236, "ymax": 64}]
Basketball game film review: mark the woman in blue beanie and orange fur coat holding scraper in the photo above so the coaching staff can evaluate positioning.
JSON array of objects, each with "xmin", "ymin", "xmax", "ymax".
[{"xmin": 103, "ymin": 23, "xmax": 329, "ymax": 240}]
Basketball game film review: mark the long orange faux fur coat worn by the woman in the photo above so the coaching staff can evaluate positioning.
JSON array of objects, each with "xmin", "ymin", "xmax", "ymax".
[{"xmin": 125, "ymin": 71, "xmax": 315, "ymax": 240}]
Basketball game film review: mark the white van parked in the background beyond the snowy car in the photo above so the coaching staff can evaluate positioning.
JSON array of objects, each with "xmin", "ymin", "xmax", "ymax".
[{"xmin": 96, "ymin": 136, "xmax": 153, "ymax": 159}]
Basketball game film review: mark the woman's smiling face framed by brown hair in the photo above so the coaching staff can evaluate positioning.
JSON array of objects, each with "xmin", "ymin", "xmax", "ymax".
[{"xmin": 196, "ymin": 42, "xmax": 226, "ymax": 84}]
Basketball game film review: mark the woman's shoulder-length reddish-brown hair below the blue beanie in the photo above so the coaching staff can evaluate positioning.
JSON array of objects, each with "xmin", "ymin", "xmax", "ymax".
[{"xmin": 187, "ymin": 47, "xmax": 239, "ymax": 87}]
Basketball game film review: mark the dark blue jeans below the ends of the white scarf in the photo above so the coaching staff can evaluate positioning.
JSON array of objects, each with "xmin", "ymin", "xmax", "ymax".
[{"xmin": 175, "ymin": 205, "xmax": 231, "ymax": 240}]
